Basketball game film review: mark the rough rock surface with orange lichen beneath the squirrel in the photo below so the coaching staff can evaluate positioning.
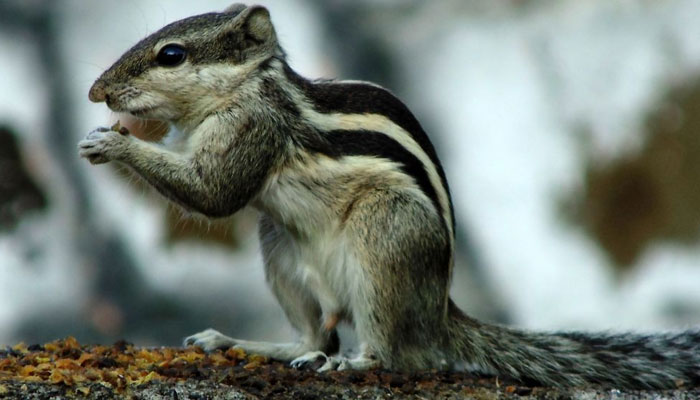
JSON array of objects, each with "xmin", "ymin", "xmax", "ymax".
[{"xmin": 0, "ymin": 338, "xmax": 700, "ymax": 400}]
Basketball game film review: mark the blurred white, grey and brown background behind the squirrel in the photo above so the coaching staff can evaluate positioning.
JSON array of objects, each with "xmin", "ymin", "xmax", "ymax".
[{"xmin": 0, "ymin": 0, "xmax": 700, "ymax": 345}]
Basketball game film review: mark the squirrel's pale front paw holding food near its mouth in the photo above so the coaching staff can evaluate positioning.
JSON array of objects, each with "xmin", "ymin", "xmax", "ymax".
[{"xmin": 78, "ymin": 123, "xmax": 129, "ymax": 164}]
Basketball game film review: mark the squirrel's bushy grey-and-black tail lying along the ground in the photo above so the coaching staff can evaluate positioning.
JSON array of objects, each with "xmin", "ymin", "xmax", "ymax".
[{"xmin": 450, "ymin": 303, "xmax": 700, "ymax": 389}]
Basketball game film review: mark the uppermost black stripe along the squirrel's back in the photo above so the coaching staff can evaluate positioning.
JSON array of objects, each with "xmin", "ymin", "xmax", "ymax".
[{"xmin": 284, "ymin": 63, "xmax": 455, "ymax": 233}]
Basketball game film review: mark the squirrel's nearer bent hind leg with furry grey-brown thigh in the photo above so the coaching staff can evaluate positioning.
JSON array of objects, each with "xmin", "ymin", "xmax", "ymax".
[{"xmin": 321, "ymin": 190, "xmax": 450, "ymax": 370}]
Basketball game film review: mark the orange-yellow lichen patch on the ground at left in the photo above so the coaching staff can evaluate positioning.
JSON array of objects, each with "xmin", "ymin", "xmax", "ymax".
[{"xmin": 0, "ymin": 337, "xmax": 268, "ymax": 395}]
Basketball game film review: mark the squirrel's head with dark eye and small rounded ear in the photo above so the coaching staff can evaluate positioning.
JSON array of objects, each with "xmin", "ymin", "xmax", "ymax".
[{"xmin": 89, "ymin": 4, "xmax": 284, "ymax": 122}]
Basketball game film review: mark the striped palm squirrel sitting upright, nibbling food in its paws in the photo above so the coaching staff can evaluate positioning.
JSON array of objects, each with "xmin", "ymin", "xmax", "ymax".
[{"xmin": 78, "ymin": 4, "xmax": 700, "ymax": 389}]
